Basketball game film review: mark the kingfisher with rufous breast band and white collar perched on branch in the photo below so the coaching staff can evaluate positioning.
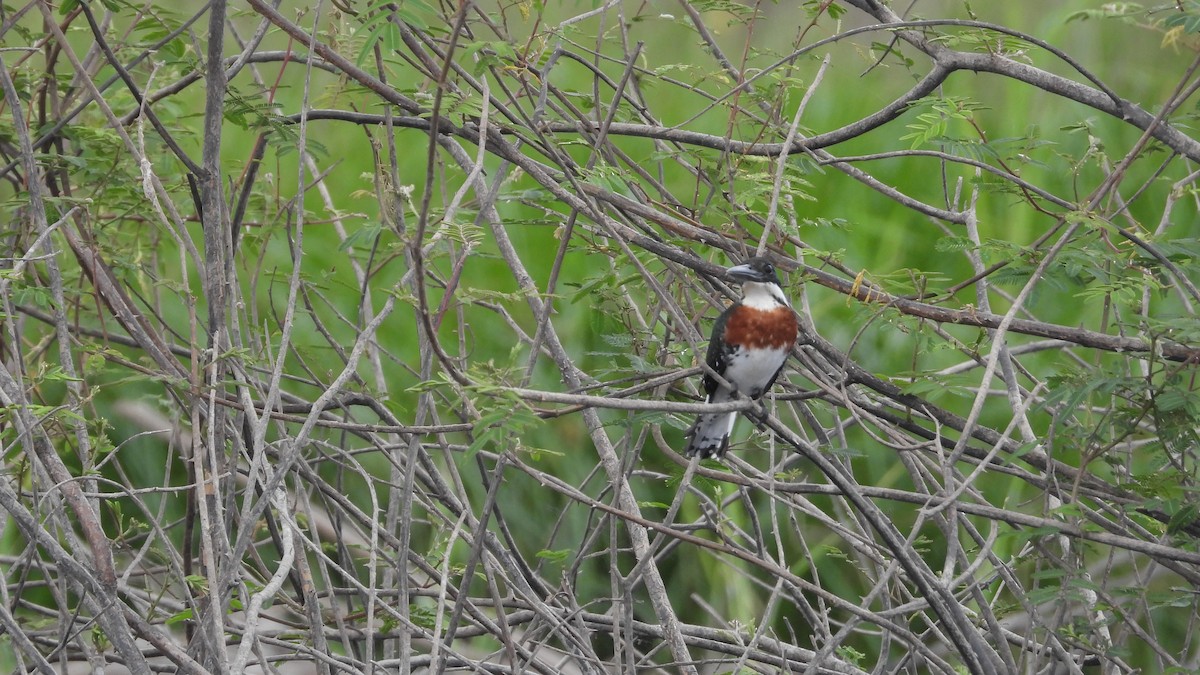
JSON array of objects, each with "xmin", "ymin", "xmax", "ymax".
[{"xmin": 684, "ymin": 258, "xmax": 799, "ymax": 459}]
